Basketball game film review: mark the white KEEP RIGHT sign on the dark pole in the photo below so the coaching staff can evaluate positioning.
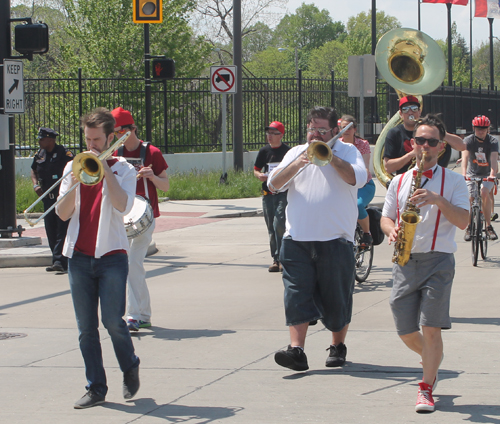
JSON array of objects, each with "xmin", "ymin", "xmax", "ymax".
[{"xmin": 3, "ymin": 59, "xmax": 24, "ymax": 114}]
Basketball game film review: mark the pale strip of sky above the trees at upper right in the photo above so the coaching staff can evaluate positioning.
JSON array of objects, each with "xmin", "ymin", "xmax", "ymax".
[{"xmin": 287, "ymin": 0, "xmax": 500, "ymax": 49}]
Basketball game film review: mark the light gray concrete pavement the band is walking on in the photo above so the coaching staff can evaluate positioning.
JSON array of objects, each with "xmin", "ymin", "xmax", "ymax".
[{"xmin": 0, "ymin": 183, "xmax": 500, "ymax": 424}]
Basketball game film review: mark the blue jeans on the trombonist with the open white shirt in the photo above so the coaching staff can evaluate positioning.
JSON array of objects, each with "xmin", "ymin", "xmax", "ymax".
[{"xmin": 68, "ymin": 252, "xmax": 139, "ymax": 396}]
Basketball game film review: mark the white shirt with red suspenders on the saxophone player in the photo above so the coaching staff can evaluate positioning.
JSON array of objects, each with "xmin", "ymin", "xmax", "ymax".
[{"xmin": 382, "ymin": 166, "xmax": 470, "ymax": 253}]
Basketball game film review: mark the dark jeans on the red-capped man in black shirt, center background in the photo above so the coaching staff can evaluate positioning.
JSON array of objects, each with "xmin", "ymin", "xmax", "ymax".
[{"xmin": 262, "ymin": 191, "xmax": 288, "ymax": 262}]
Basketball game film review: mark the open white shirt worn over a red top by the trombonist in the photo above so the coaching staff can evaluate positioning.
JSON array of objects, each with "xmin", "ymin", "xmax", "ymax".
[{"xmin": 59, "ymin": 157, "xmax": 137, "ymax": 258}]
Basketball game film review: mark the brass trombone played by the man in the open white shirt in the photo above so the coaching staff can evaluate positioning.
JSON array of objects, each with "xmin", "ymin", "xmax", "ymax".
[{"xmin": 24, "ymin": 131, "xmax": 132, "ymax": 227}]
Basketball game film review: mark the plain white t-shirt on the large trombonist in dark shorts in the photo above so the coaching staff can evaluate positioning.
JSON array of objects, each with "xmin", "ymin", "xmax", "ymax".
[{"xmin": 268, "ymin": 140, "xmax": 366, "ymax": 241}]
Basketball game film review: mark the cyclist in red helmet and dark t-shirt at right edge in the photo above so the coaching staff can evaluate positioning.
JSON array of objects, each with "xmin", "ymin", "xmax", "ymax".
[{"xmin": 462, "ymin": 115, "xmax": 498, "ymax": 241}]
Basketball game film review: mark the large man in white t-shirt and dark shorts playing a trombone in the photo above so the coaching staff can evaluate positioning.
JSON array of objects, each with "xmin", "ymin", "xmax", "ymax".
[{"xmin": 268, "ymin": 107, "xmax": 367, "ymax": 371}]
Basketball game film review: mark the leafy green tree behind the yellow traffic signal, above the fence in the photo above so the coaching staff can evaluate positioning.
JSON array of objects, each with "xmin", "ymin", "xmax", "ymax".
[{"xmin": 59, "ymin": 0, "xmax": 210, "ymax": 77}]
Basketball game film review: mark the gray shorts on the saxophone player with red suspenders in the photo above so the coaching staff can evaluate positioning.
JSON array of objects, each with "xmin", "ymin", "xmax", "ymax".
[{"xmin": 390, "ymin": 252, "xmax": 455, "ymax": 336}]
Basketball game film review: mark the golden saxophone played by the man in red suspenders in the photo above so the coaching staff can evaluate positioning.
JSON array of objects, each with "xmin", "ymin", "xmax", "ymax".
[{"xmin": 392, "ymin": 151, "xmax": 427, "ymax": 266}]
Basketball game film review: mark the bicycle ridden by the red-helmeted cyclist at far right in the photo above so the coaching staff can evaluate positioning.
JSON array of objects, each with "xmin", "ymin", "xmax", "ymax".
[{"xmin": 465, "ymin": 177, "xmax": 492, "ymax": 266}]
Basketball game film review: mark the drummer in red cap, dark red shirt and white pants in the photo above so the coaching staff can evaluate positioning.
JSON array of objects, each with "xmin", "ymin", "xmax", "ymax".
[{"xmin": 111, "ymin": 107, "xmax": 170, "ymax": 331}]
